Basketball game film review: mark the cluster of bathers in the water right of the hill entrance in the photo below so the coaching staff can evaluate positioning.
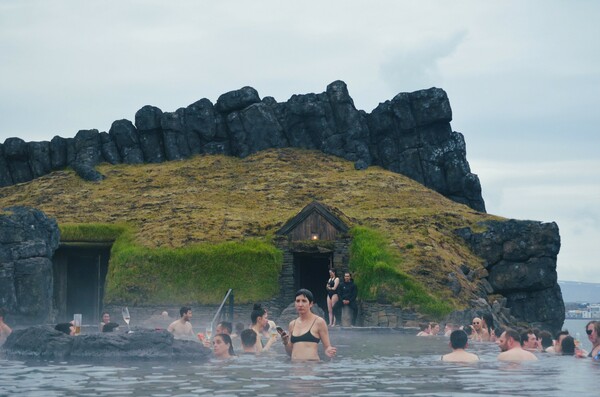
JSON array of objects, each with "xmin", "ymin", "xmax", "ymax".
[{"xmin": 417, "ymin": 314, "xmax": 600, "ymax": 362}]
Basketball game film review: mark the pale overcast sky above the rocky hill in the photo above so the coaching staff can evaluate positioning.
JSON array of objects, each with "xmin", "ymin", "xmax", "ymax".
[{"xmin": 0, "ymin": 0, "xmax": 600, "ymax": 283}]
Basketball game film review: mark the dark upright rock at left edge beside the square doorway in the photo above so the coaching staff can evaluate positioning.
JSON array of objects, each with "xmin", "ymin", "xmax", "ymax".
[{"xmin": 0, "ymin": 207, "xmax": 59, "ymax": 324}]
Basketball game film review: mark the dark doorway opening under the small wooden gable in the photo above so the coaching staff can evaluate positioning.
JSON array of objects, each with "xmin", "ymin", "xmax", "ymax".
[{"xmin": 294, "ymin": 252, "xmax": 333, "ymax": 313}]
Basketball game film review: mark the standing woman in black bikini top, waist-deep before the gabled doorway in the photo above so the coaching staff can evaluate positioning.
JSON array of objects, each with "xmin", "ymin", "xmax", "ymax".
[{"xmin": 281, "ymin": 289, "xmax": 337, "ymax": 361}]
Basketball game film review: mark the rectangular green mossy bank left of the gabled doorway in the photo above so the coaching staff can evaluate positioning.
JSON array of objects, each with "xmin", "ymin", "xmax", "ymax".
[{"xmin": 105, "ymin": 235, "xmax": 282, "ymax": 305}]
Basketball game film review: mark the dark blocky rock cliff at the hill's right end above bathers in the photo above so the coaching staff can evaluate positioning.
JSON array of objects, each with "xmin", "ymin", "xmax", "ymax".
[{"xmin": 457, "ymin": 220, "xmax": 565, "ymax": 333}]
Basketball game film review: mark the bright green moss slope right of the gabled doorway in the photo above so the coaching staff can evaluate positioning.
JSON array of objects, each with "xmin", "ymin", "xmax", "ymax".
[{"xmin": 350, "ymin": 227, "xmax": 454, "ymax": 318}]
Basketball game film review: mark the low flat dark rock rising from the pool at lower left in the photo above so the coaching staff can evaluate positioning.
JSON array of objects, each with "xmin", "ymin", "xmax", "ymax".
[{"xmin": 0, "ymin": 326, "xmax": 211, "ymax": 362}]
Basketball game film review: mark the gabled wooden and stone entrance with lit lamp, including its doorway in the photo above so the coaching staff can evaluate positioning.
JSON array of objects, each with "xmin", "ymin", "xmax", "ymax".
[{"xmin": 276, "ymin": 201, "xmax": 350, "ymax": 310}]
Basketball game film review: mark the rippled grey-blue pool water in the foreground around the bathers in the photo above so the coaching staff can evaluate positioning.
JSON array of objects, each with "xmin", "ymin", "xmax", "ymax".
[{"xmin": 0, "ymin": 330, "xmax": 600, "ymax": 397}]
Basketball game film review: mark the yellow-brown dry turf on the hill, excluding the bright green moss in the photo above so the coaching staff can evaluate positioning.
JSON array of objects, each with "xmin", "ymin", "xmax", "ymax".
[{"xmin": 0, "ymin": 149, "xmax": 499, "ymax": 305}]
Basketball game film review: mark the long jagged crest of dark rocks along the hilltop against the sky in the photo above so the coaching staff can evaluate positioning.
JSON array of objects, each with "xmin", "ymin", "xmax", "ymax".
[{"xmin": 0, "ymin": 81, "xmax": 485, "ymax": 212}]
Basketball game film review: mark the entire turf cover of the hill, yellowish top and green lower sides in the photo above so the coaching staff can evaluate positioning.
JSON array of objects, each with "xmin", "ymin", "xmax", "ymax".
[{"xmin": 0, "ymin": 149, "xmax": 498, "ymax": 314}]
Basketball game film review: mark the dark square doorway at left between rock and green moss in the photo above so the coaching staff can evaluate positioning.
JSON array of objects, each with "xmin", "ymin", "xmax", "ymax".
[{"xmin": 53, "ymin": 244, "xmax": 110, "ymax": 325}]
